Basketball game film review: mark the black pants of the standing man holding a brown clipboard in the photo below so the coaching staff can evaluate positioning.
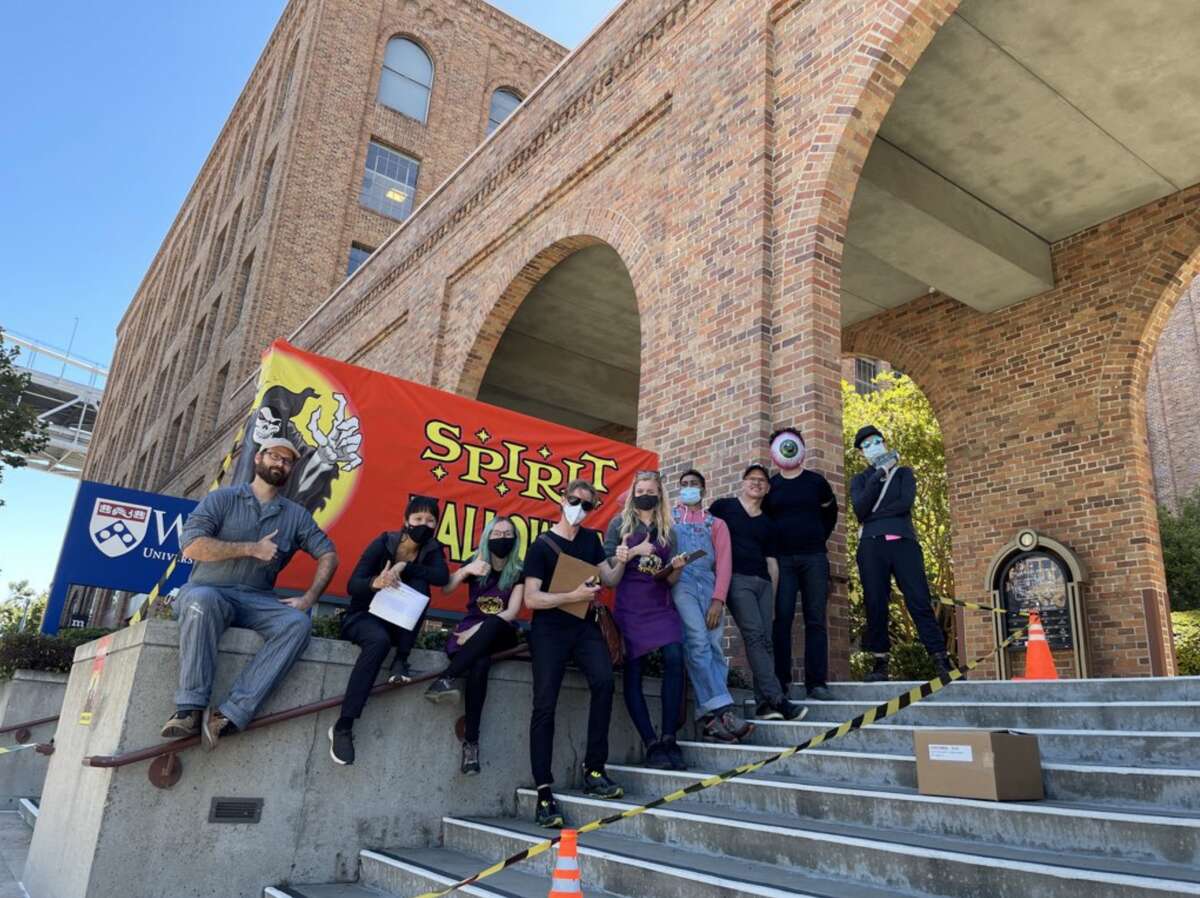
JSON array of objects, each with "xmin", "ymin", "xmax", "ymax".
[{"xmin": 529, "ymin": 609, "xmax": 613, "ymax": 786}]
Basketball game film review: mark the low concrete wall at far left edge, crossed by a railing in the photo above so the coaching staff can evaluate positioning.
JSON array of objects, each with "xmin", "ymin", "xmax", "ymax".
[{"xmin": 0, "ymin": 670, "xmax": 67, "ymax": 809}]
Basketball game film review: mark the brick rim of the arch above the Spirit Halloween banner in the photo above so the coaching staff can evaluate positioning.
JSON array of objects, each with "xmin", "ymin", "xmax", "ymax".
[{"xmin": 446, "ymin": 208, "xmax": 659, "ymax": 397}]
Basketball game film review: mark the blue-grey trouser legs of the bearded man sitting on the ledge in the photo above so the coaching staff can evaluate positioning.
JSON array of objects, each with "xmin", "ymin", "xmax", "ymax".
[{"xmin": 175, "ymin": 585, "xmax": 312, "ymax": 730}]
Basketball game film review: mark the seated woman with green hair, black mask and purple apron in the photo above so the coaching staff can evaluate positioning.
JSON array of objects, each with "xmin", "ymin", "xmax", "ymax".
[{"xmin": 425, "ymin": 517, "xmax": 524, "ymax": 776}]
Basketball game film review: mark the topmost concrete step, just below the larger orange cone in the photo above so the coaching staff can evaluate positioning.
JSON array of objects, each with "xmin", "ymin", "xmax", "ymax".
[{"xmin": 787, "ymin": 677, "xmax": 1200, "ymax": 705}]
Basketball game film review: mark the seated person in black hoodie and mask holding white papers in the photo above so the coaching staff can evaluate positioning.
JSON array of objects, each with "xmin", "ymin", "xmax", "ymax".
[{"xmin": 329, "ymin": 496, "xmax": 450, "ymax": 765}]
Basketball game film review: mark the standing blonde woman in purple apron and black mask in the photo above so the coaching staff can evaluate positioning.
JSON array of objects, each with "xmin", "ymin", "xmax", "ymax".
[{"xmin": 605, "ymin": 471, "xmax": 686, "ymax": 770}]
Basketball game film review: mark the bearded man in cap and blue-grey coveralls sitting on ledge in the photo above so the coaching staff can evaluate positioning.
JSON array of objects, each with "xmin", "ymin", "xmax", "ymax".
[{"xmin": 162, "ymin": 438, "xmax": 337, "ymax": 752}]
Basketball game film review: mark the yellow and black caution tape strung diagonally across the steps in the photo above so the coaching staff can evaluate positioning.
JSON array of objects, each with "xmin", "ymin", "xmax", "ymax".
[{"xmin": 415, "ymin": 598, "xmax": 1028, "ymax": 898}]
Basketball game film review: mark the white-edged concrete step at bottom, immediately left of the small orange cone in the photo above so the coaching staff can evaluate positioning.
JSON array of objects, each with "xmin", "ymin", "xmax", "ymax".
[{"xmin": 355, "ymin": 849, "xmax": 619, "ymax": 898}]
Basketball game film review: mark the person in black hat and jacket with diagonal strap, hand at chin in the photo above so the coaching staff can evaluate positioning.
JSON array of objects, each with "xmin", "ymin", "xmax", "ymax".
[{"xmin": 850, "ymin": 424, "xmax": 950, "ymax": 682}]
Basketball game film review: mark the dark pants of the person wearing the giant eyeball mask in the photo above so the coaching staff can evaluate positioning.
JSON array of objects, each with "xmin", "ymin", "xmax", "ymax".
[{"xmin": 772, "ymin": 552, "xmax": 829, "ymax": 694}]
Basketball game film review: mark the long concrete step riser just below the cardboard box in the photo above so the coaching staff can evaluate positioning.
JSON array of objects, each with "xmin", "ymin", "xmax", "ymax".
[{"xmin": 590, "ymin": 765, "xmax": 1200, "ymax": 868}]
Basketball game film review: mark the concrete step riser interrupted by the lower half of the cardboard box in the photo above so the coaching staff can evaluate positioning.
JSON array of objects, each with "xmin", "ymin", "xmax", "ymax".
[{"xmin": 679, "ymin": 741, "xmax": 1200, "ymax": 814}]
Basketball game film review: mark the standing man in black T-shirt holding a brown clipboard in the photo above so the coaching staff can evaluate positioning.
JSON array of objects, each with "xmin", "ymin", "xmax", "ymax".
[{"xmin": 524, "ymin": 480, "xmax": 625, "ymax": 827}]
